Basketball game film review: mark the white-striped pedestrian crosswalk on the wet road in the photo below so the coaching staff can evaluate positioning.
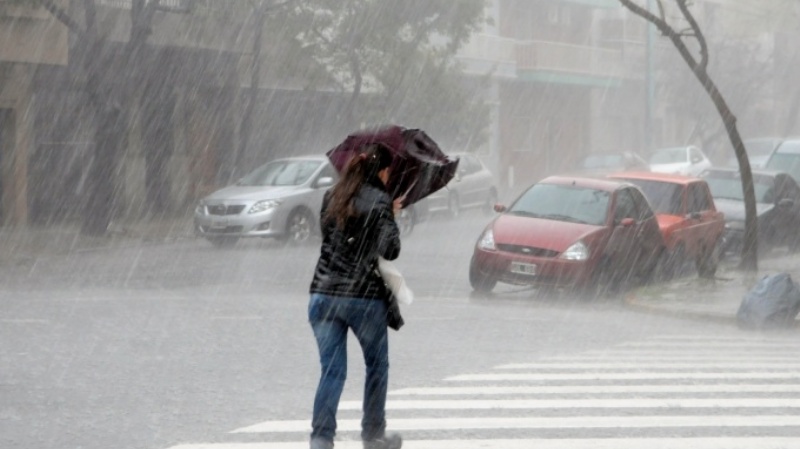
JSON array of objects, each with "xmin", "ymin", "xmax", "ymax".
[{"xmin": 162, "ymin": 334, "xmax": 800, "ymax": 449}]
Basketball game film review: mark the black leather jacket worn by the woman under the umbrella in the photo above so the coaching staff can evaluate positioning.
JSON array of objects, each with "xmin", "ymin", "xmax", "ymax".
[{"xmin": 310, "ymin": 178, "xmax": 400, "ymax": 299}]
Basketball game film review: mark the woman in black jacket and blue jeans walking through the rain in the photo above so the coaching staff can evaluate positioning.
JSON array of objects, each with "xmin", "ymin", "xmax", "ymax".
[{"xmin": 308, "ymin": 144, "xmax": 403, "ymax": 449}]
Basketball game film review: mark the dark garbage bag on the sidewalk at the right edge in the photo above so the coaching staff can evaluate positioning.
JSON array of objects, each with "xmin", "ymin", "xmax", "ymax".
[{"xmin": 736, "ymin": 273, "xmax": 800, "ymax": 329}]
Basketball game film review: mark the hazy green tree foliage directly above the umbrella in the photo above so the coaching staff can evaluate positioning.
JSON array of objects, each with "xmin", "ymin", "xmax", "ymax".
[{"xmin": 279, "ymin": 0, "xmax": 489, "ymax": 144}]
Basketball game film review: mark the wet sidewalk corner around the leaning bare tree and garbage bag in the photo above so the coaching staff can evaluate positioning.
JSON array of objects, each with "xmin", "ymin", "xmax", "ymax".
[{"xmin": 625, "ymin": 253, "xmax": 800, "ymax": 328}]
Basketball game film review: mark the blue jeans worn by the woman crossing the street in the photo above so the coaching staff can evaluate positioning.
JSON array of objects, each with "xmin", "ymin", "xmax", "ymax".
[{"xmin": 308, "ymin": 293, "xmax": 389, "ymax": 441}]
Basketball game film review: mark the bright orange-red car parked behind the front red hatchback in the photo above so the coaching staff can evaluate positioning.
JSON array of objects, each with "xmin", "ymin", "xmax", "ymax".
[{"xmin": 609, "ymin": 172, "xmax": 725, "ymax": 277}]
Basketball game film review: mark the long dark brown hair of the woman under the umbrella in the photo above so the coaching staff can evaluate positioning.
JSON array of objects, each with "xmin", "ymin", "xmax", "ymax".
[{"xmin": 326, "ymin": 143, "xmax": 392, "ymax": 229}]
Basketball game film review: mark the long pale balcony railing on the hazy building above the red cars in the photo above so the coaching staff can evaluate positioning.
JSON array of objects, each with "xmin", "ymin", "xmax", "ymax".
[{"xmin": 516, "ymin": 41, "xmax": 623, "ymax": 77}]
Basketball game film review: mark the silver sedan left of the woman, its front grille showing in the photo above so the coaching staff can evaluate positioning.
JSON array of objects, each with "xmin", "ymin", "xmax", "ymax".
[{"xmin": 194, "ymin": 155, "xmax": 338, "ymax": 246}]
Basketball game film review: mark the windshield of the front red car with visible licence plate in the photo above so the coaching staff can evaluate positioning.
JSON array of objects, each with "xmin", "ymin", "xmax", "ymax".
[{"xmin": 508, "ymin": 184, "xmax": 609, "ymax": 226}]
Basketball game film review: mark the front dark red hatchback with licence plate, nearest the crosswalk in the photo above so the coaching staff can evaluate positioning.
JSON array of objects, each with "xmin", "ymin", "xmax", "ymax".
[{"xmin": 469, "ymin": 176, "xmax": 664, "ymax": 292}]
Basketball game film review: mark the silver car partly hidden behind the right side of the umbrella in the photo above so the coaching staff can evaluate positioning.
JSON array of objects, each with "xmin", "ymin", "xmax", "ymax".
[{"xmin": 422, "ymin": 153, "xmax": 497, "ymax": 218}]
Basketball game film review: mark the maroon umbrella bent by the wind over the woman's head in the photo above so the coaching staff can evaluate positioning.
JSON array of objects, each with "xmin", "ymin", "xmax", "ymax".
[{"xmin": 327, "ymin": 126, "xmax": 458, "ymax": 207}]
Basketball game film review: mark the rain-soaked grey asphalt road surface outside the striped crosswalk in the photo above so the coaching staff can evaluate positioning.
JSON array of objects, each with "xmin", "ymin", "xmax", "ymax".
[{"xmin": 0, "ymin": 212, "xmax": 752, "ymax": 449}]
